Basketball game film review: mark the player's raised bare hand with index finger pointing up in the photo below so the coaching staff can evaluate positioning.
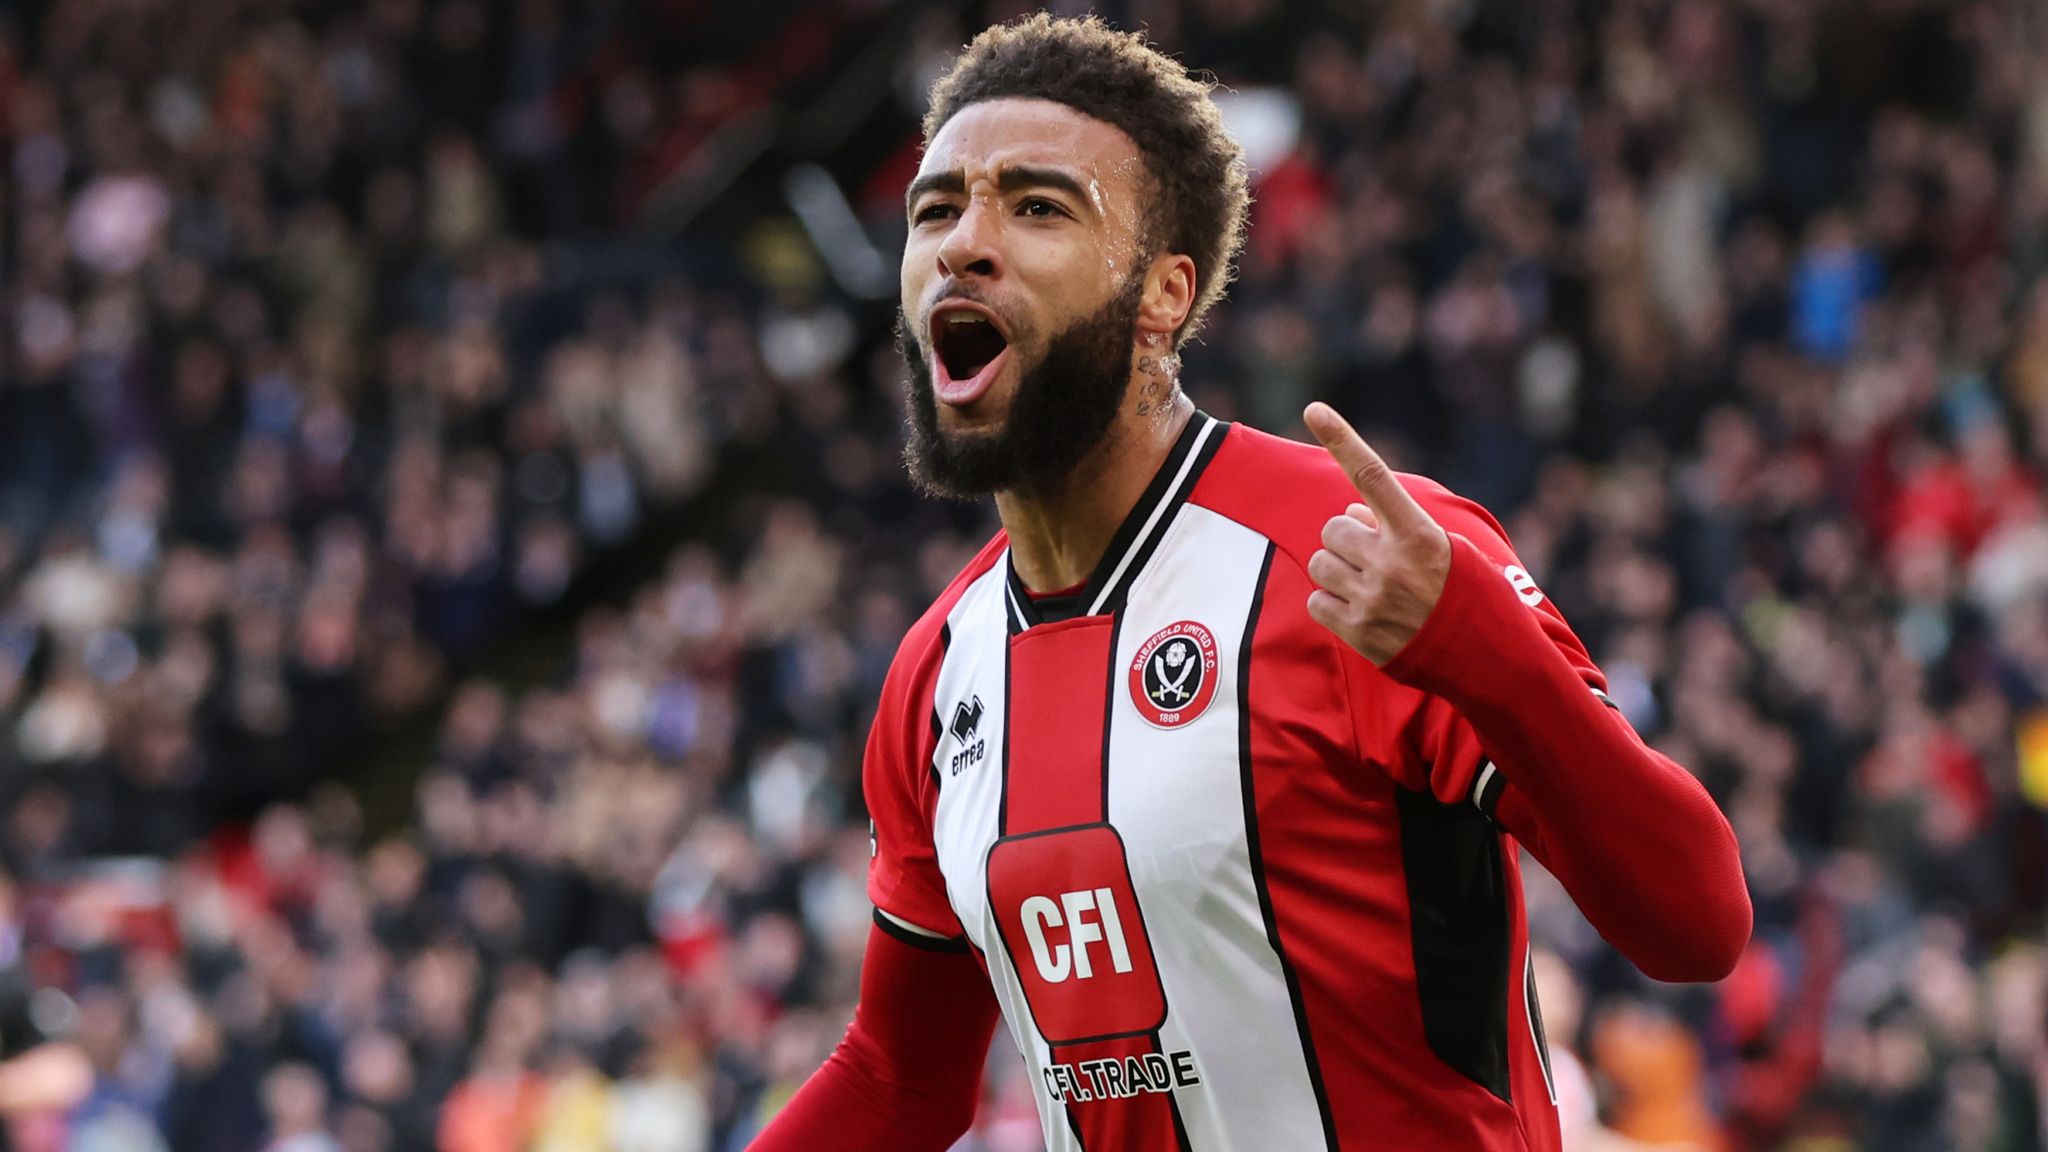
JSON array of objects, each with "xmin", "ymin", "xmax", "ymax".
[{"xmin": 1303, "ymin": 402, "xmax": 1450, "ymax": 664}]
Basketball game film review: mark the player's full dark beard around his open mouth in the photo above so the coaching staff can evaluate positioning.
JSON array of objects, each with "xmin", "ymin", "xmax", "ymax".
[{"xmin": 897, "ymin": 277, "xmax": 1145, "ymax": 500}]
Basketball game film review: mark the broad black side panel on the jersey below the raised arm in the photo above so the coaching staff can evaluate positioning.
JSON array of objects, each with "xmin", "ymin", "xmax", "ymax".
[{"xmin": 1395, "ymin": 787, "xmax": 1513, "ymax": 1103}]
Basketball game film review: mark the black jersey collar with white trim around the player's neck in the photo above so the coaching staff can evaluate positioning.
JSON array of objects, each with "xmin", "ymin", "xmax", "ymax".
[{"xmin": 1004, "ymin": 410, "xmax": 1231, "ymax": 635}]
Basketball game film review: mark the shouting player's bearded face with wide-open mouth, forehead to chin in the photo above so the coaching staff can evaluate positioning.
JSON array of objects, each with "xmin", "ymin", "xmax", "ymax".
[{"xmin": 899, "ymin": 100, "xmax": 1147, "ymax": 496}]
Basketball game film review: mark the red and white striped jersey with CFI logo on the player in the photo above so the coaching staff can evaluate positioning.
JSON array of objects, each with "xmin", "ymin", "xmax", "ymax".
[{"xmin": 866, "ymin": 414, "xmax": 1564, "ymax": 1152}]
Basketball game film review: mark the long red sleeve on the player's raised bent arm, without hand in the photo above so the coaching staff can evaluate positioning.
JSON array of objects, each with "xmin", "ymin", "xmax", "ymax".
[{"xmin": 1382, "ymin": 528, "xmax": 1751, "ymax": 982}]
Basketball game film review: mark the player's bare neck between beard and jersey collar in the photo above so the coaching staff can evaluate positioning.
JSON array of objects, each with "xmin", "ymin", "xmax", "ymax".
[{"xmin": 995, "ymin": 387, "xmax": 1194, "ymax": 592}]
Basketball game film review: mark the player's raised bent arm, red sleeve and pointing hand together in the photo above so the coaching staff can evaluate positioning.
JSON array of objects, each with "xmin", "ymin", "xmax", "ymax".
[{"xmin": 1307, "ymin": 404, "xmax": 1751, "ymax": 980}]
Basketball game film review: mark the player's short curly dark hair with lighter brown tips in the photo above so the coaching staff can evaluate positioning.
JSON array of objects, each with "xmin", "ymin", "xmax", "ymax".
[{"xmin": 924, "ymin": 12, "xmax": 1251, "ymax": 346}]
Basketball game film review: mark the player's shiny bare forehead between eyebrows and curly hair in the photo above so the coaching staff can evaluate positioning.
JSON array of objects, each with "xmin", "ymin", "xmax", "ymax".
[{"xmin": 918, "ymin": 98, "xmax": 1145, "ymax": 193}]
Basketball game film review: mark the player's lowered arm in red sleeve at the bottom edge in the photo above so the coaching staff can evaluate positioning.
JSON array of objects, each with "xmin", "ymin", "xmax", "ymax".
[{"xmin": 752, "ymin": 920, "xmax": 997, "ymax": 1152}]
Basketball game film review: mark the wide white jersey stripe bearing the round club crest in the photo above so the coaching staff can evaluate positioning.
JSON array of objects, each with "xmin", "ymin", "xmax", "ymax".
[{"xmin": 1108, "ymin": 504, "xmax": 1325, "ymax": 1152}]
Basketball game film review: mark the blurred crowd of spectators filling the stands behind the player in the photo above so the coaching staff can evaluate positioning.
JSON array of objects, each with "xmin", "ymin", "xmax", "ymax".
[{"xmin": 0, "ymin": 0, "xmax": 2048, "ymax": 1152}]
